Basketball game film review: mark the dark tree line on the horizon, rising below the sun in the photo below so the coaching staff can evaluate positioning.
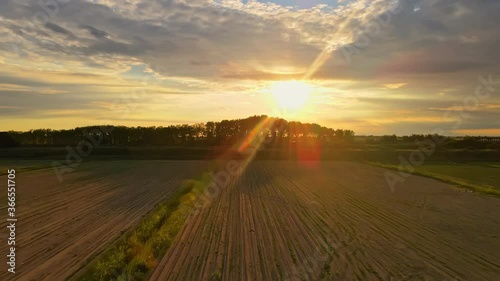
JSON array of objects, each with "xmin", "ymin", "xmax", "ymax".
[{"xmin": 0, "ymin": 115, "xmax": 354, "ymax": 147}]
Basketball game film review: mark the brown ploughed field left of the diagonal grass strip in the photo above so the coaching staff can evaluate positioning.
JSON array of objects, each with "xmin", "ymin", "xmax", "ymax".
[{"xmin": 0, "ymin": 161, "xmax": 202, "ymax": 280}]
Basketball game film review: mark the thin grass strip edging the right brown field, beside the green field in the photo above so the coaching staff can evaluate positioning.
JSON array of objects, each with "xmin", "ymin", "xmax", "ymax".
[{"xmin": 365, "ymin": 161, "xmax": 500, "ymax": 198}]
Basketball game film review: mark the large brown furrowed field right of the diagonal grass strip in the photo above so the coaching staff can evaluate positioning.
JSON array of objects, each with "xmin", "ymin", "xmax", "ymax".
[{"xmin": 150, "ymin": 161, "xmax": 500, "ymax": 281}]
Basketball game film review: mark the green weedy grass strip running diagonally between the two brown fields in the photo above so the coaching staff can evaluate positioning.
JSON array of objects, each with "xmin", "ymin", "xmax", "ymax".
[{"xmin": 76, "ymin": 174, "xmax": 210, "ymax": 281}]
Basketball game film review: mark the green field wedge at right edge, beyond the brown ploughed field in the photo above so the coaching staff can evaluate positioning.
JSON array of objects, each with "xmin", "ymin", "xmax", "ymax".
[{"xmin": 368, "ymin": 162, "xmax": 500, "ymax": 196}]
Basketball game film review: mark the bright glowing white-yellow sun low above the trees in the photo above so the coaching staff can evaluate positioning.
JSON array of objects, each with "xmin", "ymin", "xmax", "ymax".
[{"xmin": 271, "ymin": 80, "xmax": 313, "ymax": 110}]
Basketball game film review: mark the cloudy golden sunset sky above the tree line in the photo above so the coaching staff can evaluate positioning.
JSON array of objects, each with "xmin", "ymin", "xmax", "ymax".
[{"xmin": 0, "ymin": 0, "xmax": 500, "ymax": 136}]
